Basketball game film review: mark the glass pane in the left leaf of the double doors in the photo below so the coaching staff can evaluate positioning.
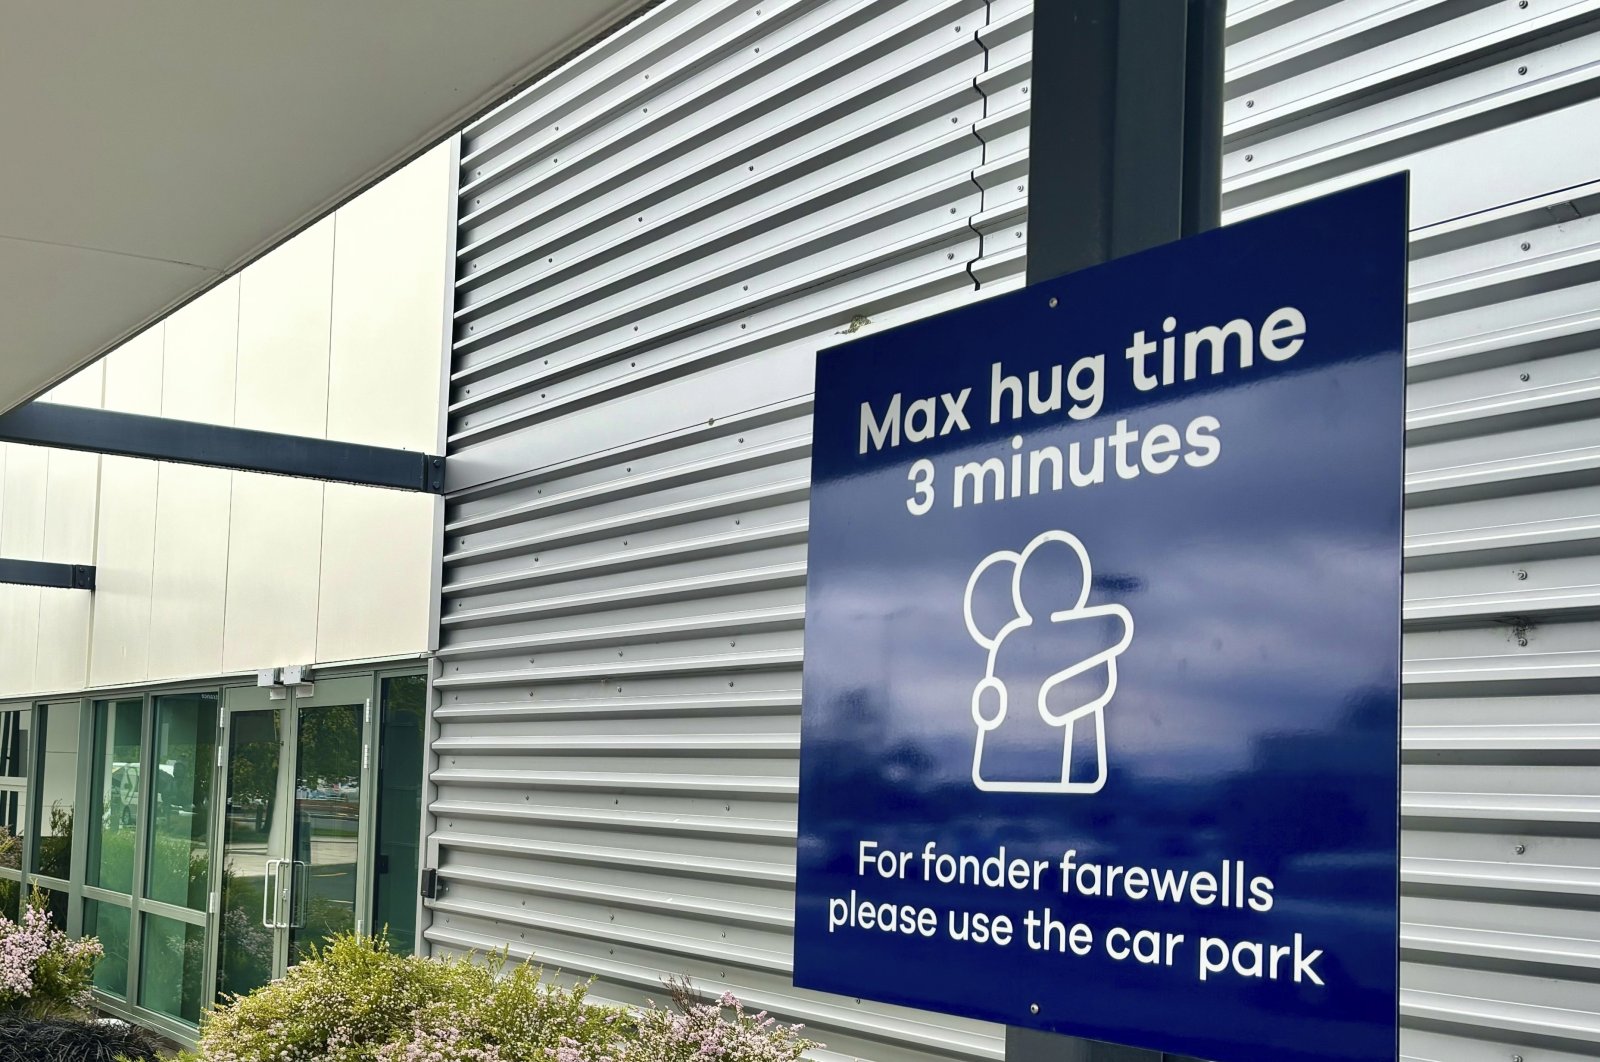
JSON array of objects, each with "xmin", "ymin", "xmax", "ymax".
[{"xmin": 216, "ymin": 709, "xmax": 286, "ymax": 1001}]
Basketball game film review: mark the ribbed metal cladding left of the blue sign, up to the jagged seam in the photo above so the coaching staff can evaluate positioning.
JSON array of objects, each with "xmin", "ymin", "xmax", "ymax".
[{"xmin": 427, "ymin": 0, "xmax": 1002, "ymax": 1060}]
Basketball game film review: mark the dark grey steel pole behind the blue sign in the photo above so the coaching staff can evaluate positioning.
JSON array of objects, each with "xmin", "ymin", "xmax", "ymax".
[{"xmin": 1005, "ymin": 0, "xmax": 1224, "ymax": 1062}]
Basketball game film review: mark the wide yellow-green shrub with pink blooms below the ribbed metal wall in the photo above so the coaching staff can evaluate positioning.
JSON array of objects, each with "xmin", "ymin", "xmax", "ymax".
[{"xmin": 187, "ymin": 936, "xmax": 816, "ymax": 1062}]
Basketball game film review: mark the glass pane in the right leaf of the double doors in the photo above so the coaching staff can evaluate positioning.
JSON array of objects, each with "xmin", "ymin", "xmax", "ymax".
[{"xmin": 290, "ymin": 704, "xmax": 365, "ymax": 963}]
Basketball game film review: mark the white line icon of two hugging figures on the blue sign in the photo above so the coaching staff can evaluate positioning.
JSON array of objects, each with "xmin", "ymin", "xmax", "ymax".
[{"xmin": 962, "ymin": 531, "xmax": 1133, "ymax": 793}]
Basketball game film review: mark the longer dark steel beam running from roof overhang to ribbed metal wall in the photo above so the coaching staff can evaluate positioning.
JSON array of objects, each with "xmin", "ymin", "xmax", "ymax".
[{"xmin": 0, "ymin": 401, "xmax": 445, "ymax": 494}]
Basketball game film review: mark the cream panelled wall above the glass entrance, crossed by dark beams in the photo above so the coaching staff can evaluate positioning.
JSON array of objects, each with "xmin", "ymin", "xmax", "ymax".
[{"xmin": 0, "ymin": 146, "xmax": 438, "ymax": 694}]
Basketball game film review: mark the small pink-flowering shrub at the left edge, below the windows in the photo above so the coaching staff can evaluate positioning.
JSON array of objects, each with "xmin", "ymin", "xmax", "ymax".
[{"xmin": 0, "ymin": 891, "xmax": 102, "ymax": 1017}]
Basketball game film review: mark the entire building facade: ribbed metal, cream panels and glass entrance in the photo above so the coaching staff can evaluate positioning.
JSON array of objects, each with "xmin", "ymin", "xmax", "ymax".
[{"xmin": 0, "ymin": 0, "xmax": 1600, "ymax": 1062}]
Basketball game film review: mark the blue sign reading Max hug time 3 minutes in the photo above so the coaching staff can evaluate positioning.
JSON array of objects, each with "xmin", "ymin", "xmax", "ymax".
[{"xmin": 795, "ymin": 178, "xmax": 1406, "ymax": 1062}]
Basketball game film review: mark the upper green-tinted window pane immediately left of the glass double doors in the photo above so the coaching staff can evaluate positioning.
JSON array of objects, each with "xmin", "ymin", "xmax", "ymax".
[{"xmin": 144, "ymin": 693, "xmax": 216, "ymax": 910}]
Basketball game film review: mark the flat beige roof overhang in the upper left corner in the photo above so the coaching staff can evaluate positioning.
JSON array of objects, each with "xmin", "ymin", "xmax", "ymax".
[{"xmin": 0, "ymin": 0, "xmax": 645, "ymax": 413}]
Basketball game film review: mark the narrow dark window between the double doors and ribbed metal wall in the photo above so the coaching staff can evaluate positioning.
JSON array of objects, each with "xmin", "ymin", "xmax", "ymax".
[{"xmin": 373, "ymin": 675, "xmax": 427, "ymax": 955}]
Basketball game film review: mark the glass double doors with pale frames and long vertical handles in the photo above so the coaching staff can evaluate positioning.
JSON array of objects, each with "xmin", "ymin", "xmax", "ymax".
[{"xmin": 216, "ymin": 677, "xmax": 373, "ymax": 1000}]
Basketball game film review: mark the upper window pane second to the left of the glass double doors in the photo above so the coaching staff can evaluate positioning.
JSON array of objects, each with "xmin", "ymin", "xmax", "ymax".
[{"xmin": 86, "ymin": 697, "xmax": 144, "ymax": 892}]
